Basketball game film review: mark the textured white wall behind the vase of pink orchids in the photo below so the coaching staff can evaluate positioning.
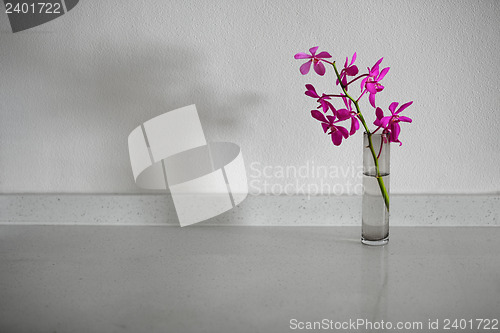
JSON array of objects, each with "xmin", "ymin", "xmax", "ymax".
[{"xmin": 0, "ymin": 0, "xmax": 500, "ymax": 193}]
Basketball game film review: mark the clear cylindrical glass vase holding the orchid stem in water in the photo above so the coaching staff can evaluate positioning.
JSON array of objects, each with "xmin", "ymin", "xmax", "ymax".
[{"xmin": 361, "ymin": 133, "xmax": 391, "ymax": 245}]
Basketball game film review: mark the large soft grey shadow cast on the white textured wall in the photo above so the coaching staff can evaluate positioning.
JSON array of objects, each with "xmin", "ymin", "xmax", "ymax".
[{"xmin": 2, "ymin": 34, "xmax": 259, "ymax": 192}]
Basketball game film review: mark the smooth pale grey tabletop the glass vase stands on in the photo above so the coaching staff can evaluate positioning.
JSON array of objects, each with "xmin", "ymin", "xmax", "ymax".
[{"xmin": 0, "ymin": 225, "xmax": 500, "ymax": 333}]
